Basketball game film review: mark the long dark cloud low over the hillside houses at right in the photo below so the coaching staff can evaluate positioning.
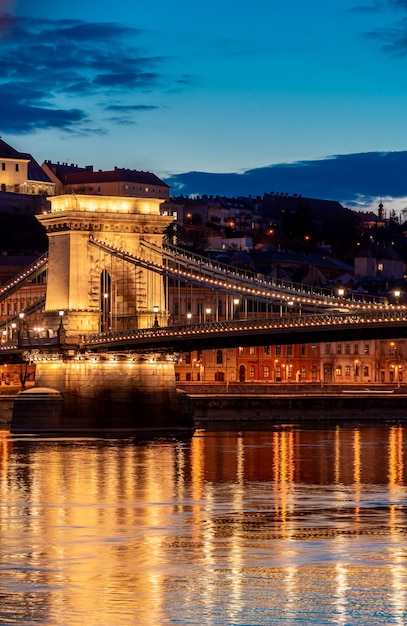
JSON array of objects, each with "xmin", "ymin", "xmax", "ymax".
[{"xmin": 166, "ymin": 151, "xmax": 407, "ymax": 206}]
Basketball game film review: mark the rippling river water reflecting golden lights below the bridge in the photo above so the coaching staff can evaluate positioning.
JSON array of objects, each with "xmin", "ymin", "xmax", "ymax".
[{"xmin": 0, "ymin": 422, "xmax": 407, "ymax": 626}]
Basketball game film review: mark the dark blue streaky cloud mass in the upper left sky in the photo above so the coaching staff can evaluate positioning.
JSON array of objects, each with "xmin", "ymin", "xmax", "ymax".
[{"xmin": 0, "ymin": 13, "xmax": 170, "ymax": 134}]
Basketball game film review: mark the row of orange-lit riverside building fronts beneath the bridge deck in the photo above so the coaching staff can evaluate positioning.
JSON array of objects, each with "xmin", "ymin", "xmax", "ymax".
[{"xmin": 175, "ymin": 339, "xmax": 407, "ymax": 389}]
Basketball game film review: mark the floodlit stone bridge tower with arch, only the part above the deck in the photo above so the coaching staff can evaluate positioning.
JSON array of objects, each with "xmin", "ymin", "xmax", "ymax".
[{"xmin": 38, "ymin": 194, "xmax": 173, "ymax": 336}]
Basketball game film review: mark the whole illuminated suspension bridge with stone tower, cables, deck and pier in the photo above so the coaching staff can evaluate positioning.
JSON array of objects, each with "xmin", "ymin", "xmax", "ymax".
[{"xmin": 0, "ymin": 190, "xmax": 407, "ymax": 431}]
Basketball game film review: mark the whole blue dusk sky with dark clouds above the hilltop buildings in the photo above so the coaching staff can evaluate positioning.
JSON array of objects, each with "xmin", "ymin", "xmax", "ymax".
[{"xmin": 0, "ymin": 0, "xmax": 407, "ymax": 208}]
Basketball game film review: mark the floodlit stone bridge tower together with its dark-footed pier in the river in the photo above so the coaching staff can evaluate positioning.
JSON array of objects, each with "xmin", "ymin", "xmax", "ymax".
[{"xmin": 11, "ymin": 194, "xmax": 193, "ymax": 433}]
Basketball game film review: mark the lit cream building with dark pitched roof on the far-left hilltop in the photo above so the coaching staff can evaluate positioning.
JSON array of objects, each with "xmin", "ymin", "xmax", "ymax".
[{"xmin": 0, "ymin": 139, "xmax": 55, "ymax": 195}]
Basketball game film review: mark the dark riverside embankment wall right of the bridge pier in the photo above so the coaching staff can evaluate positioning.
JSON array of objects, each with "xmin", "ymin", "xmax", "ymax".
[{"xmin": 177, "ymin": 383, "xmax": 407, "ymax": 424}]
